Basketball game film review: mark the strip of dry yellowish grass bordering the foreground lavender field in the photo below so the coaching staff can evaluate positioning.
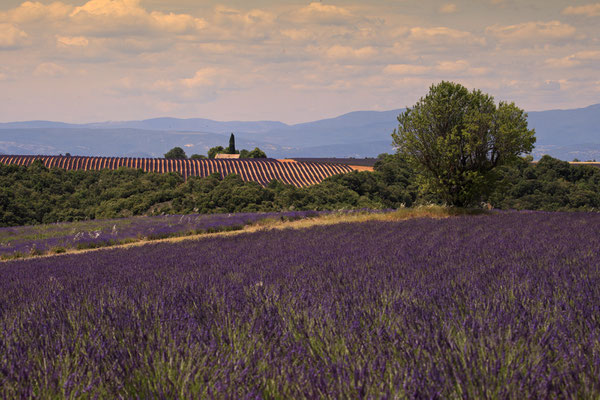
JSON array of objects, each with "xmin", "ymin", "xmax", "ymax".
[{"xmin": 0, "ymin": 205, "xmax": 487, "ymax": 262}]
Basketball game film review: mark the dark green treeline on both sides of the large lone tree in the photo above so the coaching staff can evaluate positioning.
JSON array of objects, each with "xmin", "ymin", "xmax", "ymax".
[{"xmin": 0, "ymin": 155, "xmax": 600, "ymax": 226}]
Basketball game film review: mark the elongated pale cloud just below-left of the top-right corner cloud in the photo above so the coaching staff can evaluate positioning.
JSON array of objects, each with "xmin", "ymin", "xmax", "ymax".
[{"xmin": 485, "ymin": 21, "xmax": 576, "ymax": 44}]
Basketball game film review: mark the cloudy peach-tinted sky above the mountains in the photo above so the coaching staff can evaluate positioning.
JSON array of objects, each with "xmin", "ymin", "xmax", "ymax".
[{"xmin": 0, "ymin": 0, "xmax": 600, "ymax": 123}]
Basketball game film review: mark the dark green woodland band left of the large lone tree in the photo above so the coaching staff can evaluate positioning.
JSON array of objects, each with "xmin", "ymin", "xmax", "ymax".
[{"xmin": 0, "ymin": 156, "xmax": 416, "ymax": 226}]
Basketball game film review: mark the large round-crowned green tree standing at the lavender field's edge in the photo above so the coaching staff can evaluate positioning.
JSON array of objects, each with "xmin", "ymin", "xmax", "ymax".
[{"xmin": 392, "ymin": 82, "xmax": 535, "ymax": 206}]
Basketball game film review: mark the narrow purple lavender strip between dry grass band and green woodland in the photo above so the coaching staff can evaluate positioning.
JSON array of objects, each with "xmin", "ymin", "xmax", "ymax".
[{"xmin": 0, "ymin": 211, "xmax": 322, "ymax": 258}]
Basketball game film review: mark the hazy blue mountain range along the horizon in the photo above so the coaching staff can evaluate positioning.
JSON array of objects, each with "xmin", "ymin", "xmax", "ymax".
[{"xmin": 0, "ymin": 104, "xmax": 600, "ymax": 161}]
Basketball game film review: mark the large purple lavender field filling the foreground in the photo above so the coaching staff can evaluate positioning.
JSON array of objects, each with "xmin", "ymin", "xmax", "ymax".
[{"xmin": 0, "ymin": 212, "xmax": 600, "ymax": 399}]
